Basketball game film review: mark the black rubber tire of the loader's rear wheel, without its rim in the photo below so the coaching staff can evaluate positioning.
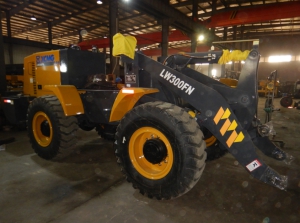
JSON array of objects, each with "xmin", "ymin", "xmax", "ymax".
[{"xmin": 27, "ymin": 95, "xmax": 78, "ymax": 160}]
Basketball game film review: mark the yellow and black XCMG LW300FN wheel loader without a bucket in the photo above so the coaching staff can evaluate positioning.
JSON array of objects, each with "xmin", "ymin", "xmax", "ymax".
[{"xmin": 0, "ymin": 34, "xmax": 291, "ymax": 199}]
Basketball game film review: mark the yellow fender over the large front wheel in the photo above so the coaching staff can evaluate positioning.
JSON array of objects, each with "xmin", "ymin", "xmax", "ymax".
[{"xmin": 109, "ymin": 88, "xmax": 159, "ymax": 122}]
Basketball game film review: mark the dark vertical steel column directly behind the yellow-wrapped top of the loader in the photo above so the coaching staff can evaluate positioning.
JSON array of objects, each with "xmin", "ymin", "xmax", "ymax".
[{"xmin": 109, "ymin": 0, "xmax": 120, "ymax": 77}]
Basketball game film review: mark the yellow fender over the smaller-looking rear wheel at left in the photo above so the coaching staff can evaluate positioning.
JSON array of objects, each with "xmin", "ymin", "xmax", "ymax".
[{"xmin": 44, "ymin": 85, "xmax": 84, "ymax": 116}]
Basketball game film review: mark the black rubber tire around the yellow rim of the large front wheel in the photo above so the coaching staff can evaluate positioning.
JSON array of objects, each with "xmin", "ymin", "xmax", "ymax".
[{"xmin": 114, "ymin": 101, "xmax": 206, "ymax": 200}]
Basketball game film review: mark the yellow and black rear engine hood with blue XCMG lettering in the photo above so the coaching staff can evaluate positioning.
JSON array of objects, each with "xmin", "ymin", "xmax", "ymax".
[{"xmin": 23, "ymin": 48, "xmax": 106, "ymax": 97}]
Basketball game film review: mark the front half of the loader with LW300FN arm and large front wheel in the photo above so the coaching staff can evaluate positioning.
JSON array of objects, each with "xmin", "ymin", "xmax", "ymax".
[{"xmin": 111, "ymin": 34, "xmax": 292, "ymax": 199}]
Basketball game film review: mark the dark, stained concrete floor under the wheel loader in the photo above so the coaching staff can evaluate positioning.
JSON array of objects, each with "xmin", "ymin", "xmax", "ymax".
[{"xmin": 0, "ymin": 98, "xmax": 300, "ymax": 223}]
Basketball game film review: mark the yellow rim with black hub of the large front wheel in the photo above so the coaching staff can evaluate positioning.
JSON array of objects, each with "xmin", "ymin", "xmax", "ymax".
[{"xmin": 129, "ymin": 127, "xmax": 174, "ymax": 180}]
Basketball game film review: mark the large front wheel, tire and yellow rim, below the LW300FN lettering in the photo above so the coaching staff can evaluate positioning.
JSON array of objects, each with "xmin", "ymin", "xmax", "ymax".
[{"xmin": 114, "ymin": 102, "xmax": 206, "ymax": 199}]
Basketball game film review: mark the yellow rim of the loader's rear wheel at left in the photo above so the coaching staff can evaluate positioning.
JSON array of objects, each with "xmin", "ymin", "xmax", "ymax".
[{"xmin": 32, "ymin": 112, "xmax": 53, "ymax": 147}]
